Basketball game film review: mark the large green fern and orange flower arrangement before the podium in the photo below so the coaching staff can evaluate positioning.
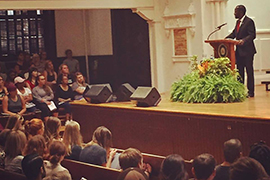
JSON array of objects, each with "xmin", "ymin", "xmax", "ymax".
[{"xmin": 171, "ymin": 56, "xmax": 247, "ymax": 103}]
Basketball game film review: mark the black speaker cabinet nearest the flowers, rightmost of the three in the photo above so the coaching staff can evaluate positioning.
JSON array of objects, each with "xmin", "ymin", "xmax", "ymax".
[{"xmin": 130, "ymin": 86, "xmax": 161, "ymax": 107}]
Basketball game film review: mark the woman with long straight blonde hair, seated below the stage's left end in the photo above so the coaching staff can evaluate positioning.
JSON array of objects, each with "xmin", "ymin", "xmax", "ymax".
[{"xmin": 63, "ymin": 120, "xmax": 83, "ymax": 161}]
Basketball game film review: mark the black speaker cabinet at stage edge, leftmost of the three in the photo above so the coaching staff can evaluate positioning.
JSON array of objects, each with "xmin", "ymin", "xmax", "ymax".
[{"xmin": 83, "ymin": 84, "xmax": 112, "ymax": 103}]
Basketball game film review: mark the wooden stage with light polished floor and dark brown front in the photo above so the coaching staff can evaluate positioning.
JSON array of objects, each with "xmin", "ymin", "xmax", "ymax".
[{"xmin": 72, "ymin": 85, "xmax": 270, "ymax": 162}]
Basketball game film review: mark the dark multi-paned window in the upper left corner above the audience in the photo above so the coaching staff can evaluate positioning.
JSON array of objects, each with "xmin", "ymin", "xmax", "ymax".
[{"xmin": 0, "ymin": 10, "xmax": 44, "ymax": 57}]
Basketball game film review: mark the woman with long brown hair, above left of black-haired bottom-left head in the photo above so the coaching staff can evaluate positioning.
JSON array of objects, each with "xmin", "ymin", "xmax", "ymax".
[{"xmin": 5, "ymin": 130, "xmax": 26, "ymax": 173}]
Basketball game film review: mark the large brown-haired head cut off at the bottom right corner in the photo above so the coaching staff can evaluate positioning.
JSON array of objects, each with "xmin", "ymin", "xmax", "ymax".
[{"xmin": 230, "ymin": 157, "xmax": 268, "ymax": 180}]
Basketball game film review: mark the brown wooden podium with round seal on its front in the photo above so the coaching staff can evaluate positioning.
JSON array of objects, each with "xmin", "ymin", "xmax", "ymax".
[{"xmin": 204, "ymin": 39, "xmax": 237, "ymax": 70}]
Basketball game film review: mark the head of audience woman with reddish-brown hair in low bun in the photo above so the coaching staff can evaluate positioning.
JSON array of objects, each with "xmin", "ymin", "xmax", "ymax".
[{"xmin": 49, "ymin": 140, "xmax": 66, "ymax": 165}]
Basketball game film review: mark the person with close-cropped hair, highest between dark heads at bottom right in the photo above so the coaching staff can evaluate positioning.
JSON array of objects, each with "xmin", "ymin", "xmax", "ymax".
[{"xmin": 214, "ymin": 139, "xmax": 242, "ymax": 180}]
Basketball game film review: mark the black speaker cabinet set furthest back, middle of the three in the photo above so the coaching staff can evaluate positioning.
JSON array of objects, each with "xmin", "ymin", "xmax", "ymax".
[{"xmin": 115, "ymin": 83, "xmax": 135, "ymax": 102}]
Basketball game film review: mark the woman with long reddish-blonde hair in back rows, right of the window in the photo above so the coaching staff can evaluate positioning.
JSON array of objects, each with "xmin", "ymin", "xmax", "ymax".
[{"xmin": 44, "ymin": 60, "xmax": 57, "ymax": 88}]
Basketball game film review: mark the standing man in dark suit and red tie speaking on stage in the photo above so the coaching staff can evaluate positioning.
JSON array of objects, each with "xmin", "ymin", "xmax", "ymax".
[{"xmin": 226, "ymin": 5, "xmax": 256, "ymax": 97}]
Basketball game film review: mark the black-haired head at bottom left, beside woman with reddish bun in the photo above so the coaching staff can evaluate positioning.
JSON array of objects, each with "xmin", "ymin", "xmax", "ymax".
[{"xmin": 22, "ymin": 153, "xmax": 46, "ymax": 180}]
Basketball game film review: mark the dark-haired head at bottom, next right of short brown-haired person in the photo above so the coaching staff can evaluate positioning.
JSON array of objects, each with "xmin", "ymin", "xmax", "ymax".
[{"xmin": 161, "ymin": 154, "xmax": 188, "ymax": 180}]
